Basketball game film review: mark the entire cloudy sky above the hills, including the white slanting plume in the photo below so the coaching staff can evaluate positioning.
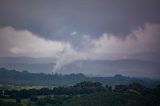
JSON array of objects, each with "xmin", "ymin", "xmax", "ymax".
[{"xmin": 0, "ymin": 0, "xmax": 160, "ymax": 75}]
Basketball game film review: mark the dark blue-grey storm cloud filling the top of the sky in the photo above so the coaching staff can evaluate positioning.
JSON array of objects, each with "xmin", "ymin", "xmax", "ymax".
[{"xmin": 0, "ymin": 0, "xmax": 160, "ymax": 40}]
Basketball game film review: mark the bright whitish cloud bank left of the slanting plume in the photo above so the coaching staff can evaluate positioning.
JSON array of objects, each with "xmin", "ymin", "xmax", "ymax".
[{"xmin": 0, "ymin": 27, "xmax": 67, "ymax": 58}]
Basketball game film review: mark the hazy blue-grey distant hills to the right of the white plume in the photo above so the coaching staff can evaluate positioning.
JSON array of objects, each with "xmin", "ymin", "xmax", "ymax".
[{"xmin": 58, "ymin": 59, "xmax": 160, "ymax": 78}]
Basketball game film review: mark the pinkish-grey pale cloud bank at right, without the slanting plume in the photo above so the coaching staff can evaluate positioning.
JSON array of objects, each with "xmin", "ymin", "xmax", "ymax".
[{"xmin": 85, "ymin": 24, "xmax": 160, "ymax": 59}]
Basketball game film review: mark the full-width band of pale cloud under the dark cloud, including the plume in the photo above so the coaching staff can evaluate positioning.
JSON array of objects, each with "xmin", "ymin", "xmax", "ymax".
[{"xmin": 0, "ymin": 23, "xmax": 160, "ymax": 70}]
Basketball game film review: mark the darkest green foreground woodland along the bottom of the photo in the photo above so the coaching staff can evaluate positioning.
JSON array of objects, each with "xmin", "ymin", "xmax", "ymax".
[{"xmin": 0, "ymin": 81, "xmax": 160, "ymax": 106}]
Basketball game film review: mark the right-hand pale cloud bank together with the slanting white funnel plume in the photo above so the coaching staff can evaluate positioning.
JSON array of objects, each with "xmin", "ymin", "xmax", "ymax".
[{"xmin": 54, "ymin": 24, "xmax": 160, "ymax": 72}]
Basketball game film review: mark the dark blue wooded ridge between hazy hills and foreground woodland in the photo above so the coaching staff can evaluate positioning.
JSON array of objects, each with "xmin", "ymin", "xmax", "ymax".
[{"xmin": 0, "ymin": 68, "xmax": 160, "ymax": 86}]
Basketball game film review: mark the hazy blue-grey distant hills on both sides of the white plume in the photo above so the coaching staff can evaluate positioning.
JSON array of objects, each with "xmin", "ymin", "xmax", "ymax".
[{"xmin": 0, "ymin": 57, "xmax": 160, "ymax": 78}]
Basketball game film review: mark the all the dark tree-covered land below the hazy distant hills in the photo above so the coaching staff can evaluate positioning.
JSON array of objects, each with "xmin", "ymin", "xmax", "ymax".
[{"xmin": 0, "ymin": 68, "xmax": 160, "ymax": 106}]
